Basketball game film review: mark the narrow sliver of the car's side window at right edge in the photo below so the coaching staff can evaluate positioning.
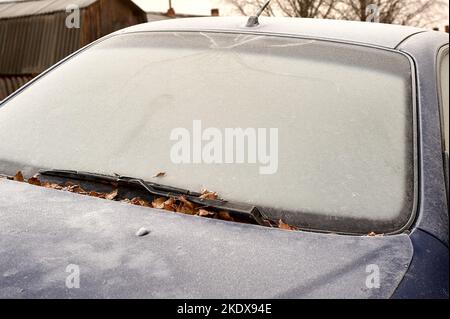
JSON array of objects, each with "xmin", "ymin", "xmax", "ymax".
[{"xmin": 439, "ymin": 48, "xmax": 449, "ymax": 197}]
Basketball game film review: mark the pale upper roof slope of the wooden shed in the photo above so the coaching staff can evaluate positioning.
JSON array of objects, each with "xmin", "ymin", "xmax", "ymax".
[{"xmin": 0, "ymin": 0, "xmax": 97, "ymax": 19}]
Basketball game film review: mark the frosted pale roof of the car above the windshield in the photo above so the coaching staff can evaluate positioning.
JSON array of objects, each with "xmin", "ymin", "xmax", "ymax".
[{"xmin": 119, "ymin": 17, "xmax": 428, "ymax": 49}]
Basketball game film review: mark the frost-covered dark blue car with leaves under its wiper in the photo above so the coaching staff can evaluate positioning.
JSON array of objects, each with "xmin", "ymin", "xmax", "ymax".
[{"xmin": 0, "ymin": 17, "xmax": 449, "ymax": 299}]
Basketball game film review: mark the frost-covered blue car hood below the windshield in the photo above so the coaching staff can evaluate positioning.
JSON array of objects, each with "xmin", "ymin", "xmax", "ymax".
[{"xmin": 0, "ymin": 180, "xmax": 413, "ymax": 298}]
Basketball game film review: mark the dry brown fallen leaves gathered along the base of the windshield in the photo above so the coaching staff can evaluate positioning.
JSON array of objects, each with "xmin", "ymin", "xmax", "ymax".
[{"xmin": 8, "ymin": 171, "xmax": 298, "ymax": 230}]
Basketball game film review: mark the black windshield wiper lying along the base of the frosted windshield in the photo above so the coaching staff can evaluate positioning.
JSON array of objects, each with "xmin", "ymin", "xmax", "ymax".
[{"xmin": 39, "ymin": 169, "xmax": 271, "ymax": 226}]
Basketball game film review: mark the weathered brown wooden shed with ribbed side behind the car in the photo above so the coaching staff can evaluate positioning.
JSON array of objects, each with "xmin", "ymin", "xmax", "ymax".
[{"xmin": 0, "ymin": 0, "xmax": 147, "ymax": 100}]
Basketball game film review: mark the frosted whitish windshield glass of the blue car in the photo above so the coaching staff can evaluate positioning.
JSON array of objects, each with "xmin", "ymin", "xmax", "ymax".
[{"xmin": 0, "ymin": 32, "xmax": 415, "ymax": 232}]
